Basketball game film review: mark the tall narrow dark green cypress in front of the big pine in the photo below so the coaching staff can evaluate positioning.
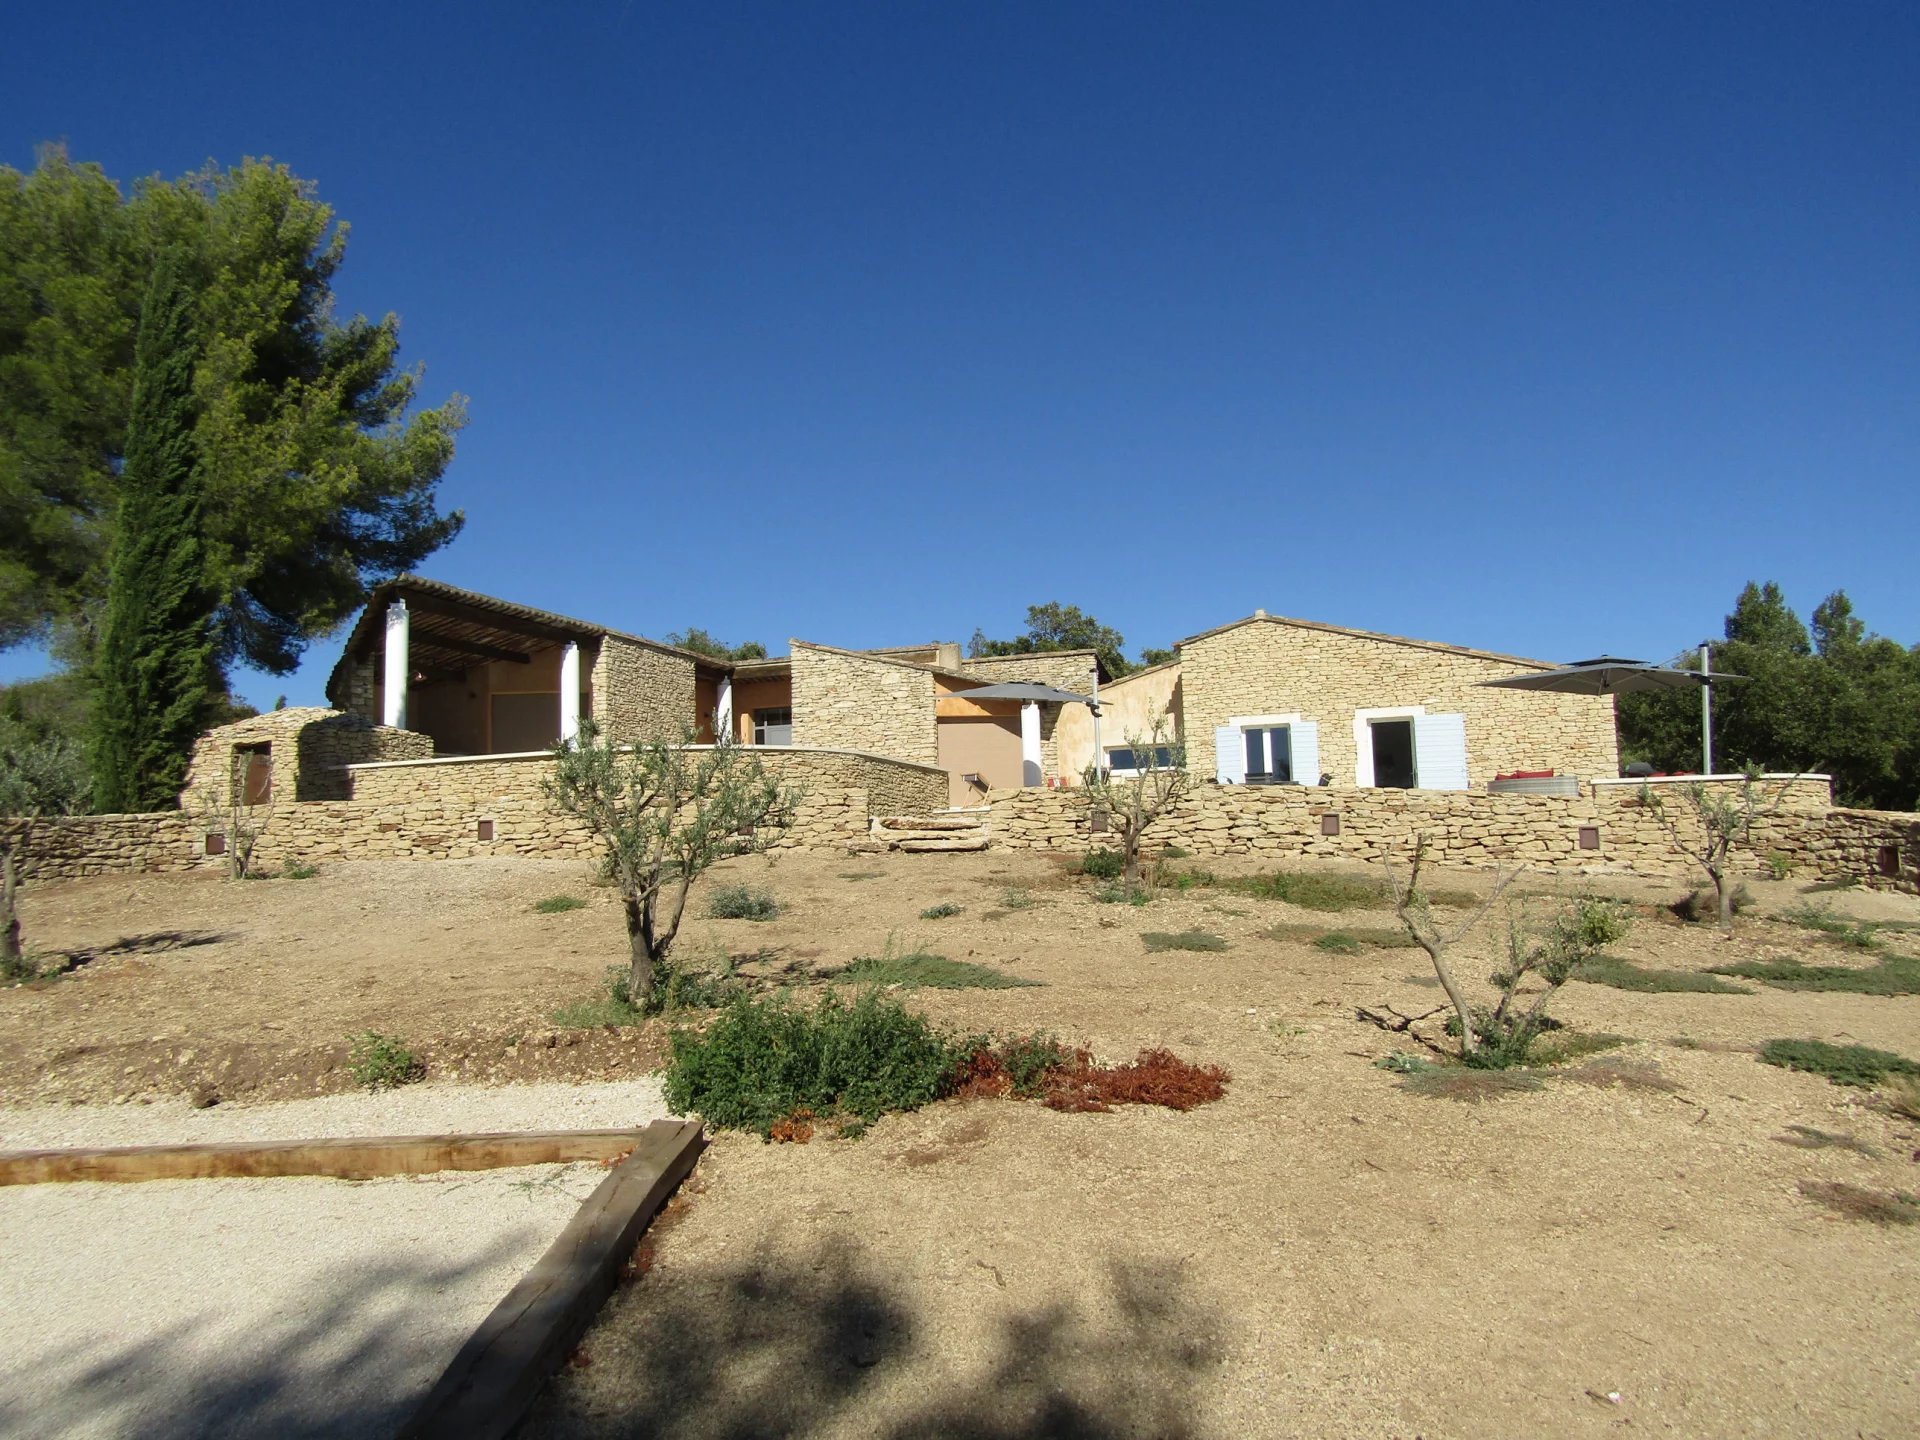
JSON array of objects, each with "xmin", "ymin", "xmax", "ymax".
[{"xmin": 90, "ymin": 250, "xmax": 215, "ymax": 812}]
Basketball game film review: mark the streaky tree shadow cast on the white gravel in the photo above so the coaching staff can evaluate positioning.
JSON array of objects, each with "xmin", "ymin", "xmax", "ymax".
[{"xmin": 0, "ymin": 1236, "xmax": 516, "ymax": 1440}]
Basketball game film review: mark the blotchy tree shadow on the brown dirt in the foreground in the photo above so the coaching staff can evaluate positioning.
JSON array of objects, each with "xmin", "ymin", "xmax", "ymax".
[{"xmin": 520, "ymin": 1238, "xmax": 1219, "ymax": 1440}]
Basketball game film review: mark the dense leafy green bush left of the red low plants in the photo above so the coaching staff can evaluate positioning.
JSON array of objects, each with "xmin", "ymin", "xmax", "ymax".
[{"xmin": 666, "ymin": 991, "xmax": 972, "ymax": 1137}]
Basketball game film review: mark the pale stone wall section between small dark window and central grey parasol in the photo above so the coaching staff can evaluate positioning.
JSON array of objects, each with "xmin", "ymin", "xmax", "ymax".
[{"xmin": 791, "ymin": 639, "xmax": 945, "ymax": 771}]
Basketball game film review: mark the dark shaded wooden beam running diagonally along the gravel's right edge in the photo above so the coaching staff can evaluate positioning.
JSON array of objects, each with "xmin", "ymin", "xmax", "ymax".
[{"xmin": 399, "ymin": 1119, "xmax": 707, "ymax": 1440}]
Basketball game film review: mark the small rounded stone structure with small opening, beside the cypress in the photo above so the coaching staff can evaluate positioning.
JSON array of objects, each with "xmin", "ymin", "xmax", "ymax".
[{"xmin": 180, "ymin": 707, "xmax": 434, "ymax": 808}]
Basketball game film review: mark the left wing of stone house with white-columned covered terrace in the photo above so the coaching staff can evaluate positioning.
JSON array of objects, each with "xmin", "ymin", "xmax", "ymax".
[{"xmin": 305, "ymin": 576, "xmax": 1098, "ymax": 804}]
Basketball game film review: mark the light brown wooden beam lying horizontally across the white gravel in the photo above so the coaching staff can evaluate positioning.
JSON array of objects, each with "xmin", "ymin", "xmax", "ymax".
[{"xmin": 0, "ymin": 1129, "xmax": 645, "ymax": 1185}]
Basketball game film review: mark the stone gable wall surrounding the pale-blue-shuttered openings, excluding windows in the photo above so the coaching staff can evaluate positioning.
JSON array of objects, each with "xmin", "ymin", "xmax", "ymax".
[{"xmin": 1181, "ymin": 620, "xmax": 1620, "ymax": 787}]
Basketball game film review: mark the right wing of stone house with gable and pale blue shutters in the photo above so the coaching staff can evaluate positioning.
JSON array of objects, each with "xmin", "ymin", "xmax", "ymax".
[{"xmin": 1060, "ymin": 611, "xmax": 1620, "ymax": 791}]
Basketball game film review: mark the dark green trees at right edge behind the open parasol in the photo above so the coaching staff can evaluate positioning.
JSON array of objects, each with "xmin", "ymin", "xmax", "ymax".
[{"xmin": 1620, "ymin": 582, "xmax": 1920, "ymax": 810}]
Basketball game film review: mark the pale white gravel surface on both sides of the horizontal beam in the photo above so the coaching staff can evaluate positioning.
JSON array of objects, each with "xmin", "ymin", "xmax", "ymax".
[{"xmin": 0, "ymin": 1081, "xmax": 675, "ymax": 1440}]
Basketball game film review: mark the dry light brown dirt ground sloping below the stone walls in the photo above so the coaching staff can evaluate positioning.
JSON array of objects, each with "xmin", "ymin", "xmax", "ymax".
[{"xmin": 0, "ymin": 852, "xmax": 1920, "ymax": 1436}]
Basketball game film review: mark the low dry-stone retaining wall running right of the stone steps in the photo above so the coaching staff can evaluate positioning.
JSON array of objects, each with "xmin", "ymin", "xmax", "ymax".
[{"xmin": 989, "ymin": 778, "xmax": 1920, "ymax": 891}]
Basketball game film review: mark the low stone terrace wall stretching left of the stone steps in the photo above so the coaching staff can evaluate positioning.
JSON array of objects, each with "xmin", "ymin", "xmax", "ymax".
[{"xmin": 0, "ymin": 749, "xmax": 947, "ymax": 879}]
